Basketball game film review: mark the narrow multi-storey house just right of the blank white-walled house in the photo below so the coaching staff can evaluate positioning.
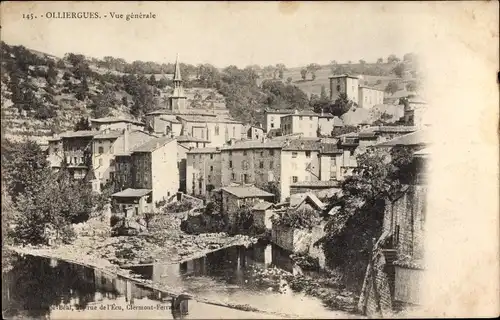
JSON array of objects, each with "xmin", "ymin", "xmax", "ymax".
[{"xmin": 186, "ymin": 148, "xmax": 222, "ymax": 196}]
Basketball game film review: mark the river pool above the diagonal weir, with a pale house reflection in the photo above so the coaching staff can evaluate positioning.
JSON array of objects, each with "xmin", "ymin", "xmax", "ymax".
[{"xmin": 125, "ymin": 243, "xmax": 347, "ymax": 318}]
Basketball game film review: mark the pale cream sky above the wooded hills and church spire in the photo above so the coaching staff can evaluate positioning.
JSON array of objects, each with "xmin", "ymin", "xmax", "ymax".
[{"xmin": 2, "ymin": 2, "xmax": 433, "ymax": 67}]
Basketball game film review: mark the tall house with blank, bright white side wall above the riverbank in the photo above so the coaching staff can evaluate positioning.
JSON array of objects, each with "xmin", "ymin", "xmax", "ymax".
[{"xmin": 114, "ymin": 137, "xmax": 179, "ymax": 212}]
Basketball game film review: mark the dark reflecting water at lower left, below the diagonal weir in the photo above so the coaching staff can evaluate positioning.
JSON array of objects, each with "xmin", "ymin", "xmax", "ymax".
[{"xmin": 2, "ymin": 256, "xmax": 280, "ymax": 319}]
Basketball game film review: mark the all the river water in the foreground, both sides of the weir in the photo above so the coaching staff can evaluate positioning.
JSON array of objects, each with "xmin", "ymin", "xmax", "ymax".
[{"xmin": 2, "ymin": 244, "xmax": 354, "ymax": 319}]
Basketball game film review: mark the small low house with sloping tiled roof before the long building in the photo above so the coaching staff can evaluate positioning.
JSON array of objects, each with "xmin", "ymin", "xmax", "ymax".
[{"xmin": 221, "ymin": 185, "xmax": 274, "ymax": 224}]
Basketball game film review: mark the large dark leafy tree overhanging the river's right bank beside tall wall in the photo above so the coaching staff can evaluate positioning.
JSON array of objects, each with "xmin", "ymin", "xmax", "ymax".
[{"xmin": 320, "ymin": 147, "xmax": 416, "ymax": 285}]
